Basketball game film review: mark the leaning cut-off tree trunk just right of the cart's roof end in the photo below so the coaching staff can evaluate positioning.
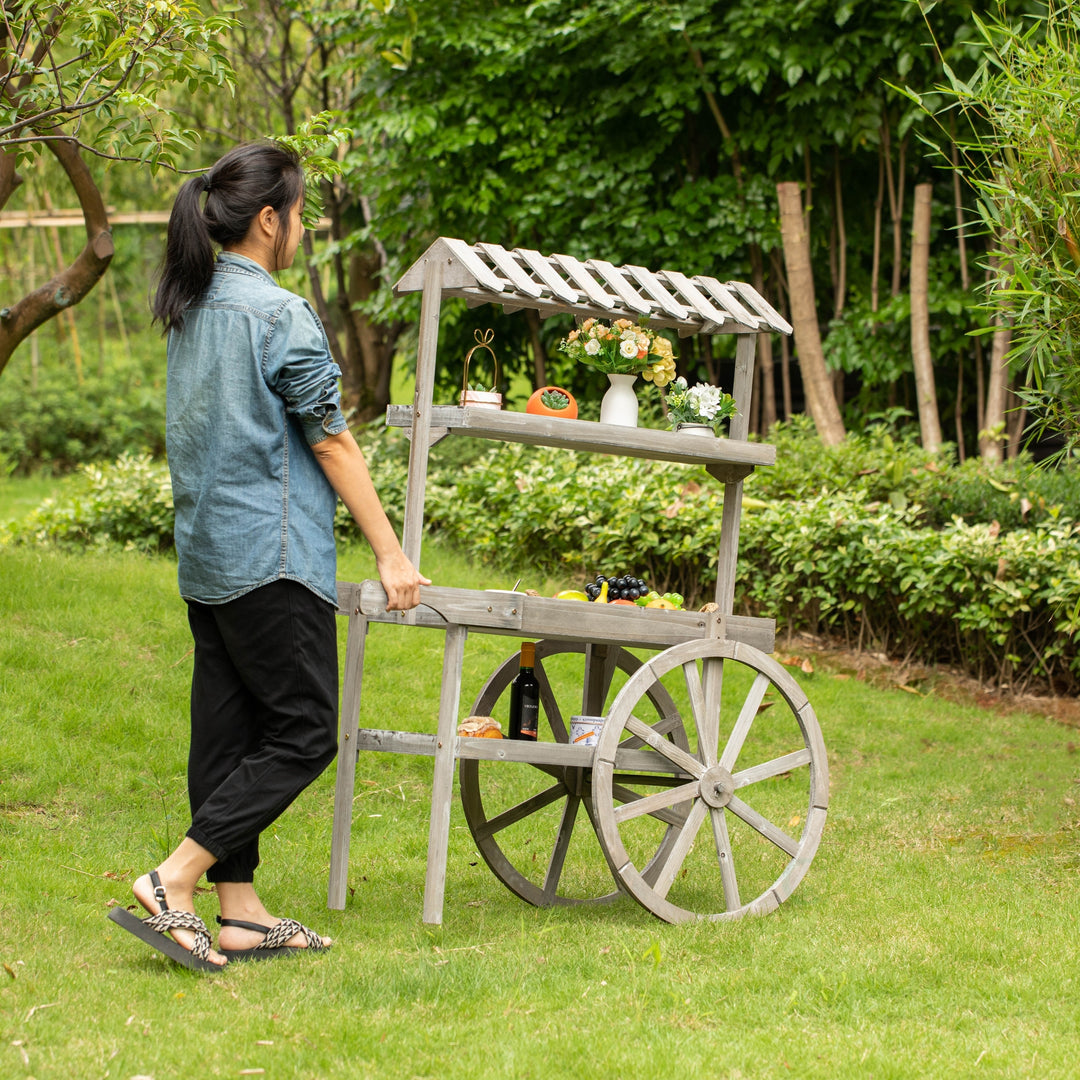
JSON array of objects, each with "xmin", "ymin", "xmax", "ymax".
[{"xmin": 777, "ymin": 181, "xmax": 845, "ymax": 446}]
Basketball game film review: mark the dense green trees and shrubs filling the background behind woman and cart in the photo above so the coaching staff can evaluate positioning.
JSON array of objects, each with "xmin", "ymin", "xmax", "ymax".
[{"xmin": 0, "ymin": 0, "xmax": 1080, "ymax": 687}]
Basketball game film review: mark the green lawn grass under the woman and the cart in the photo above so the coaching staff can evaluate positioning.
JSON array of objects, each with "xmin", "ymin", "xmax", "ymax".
[{"xmin": 0, "ymin": 544, "xmax": 1080, "ymax": 1080}]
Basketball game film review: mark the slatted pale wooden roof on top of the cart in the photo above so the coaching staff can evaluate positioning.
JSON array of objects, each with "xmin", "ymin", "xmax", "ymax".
[{"xmin": 394, "ymin": 237, "xmax": 792, "ymax": 337}]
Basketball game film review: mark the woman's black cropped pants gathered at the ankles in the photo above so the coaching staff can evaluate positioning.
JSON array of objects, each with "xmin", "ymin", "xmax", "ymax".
[{"xmin": 187, "ymin": 579, "xmax": 338, "ymax": 881}]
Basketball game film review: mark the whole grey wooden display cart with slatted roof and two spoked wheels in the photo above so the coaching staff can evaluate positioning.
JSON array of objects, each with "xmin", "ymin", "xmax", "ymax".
[{"xmin": 328, "ymin": 238, "xmax": 828, "ymax": 923}]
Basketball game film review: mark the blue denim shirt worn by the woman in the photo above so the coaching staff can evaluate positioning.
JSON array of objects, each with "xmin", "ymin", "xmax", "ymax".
[{"xmin": 165, "ymin": 252, "xmax": 348, "ymax": 604}]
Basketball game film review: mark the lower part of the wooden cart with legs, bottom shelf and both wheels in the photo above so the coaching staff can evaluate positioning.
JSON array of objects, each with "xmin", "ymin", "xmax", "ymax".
[{"xmin": 329, "ymin": 591, "xmax": 828, "ymax": 923}]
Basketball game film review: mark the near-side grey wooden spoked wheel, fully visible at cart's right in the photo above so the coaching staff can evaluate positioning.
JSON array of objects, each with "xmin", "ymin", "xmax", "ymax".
[{"xmin": 593, "ymin": 638, "xmax": 828, "ymax": 922}]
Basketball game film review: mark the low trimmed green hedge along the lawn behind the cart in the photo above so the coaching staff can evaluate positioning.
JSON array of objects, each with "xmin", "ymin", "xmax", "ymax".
[{"xmin": 8, "ymin": 432, "xmax": 1080, "ymax": 691}]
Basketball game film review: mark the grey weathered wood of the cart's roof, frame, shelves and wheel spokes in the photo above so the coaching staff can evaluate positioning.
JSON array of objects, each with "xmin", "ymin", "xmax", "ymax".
[{"xmin": 330, "ymin": 237, "xmax": 827, "ymax": 923}]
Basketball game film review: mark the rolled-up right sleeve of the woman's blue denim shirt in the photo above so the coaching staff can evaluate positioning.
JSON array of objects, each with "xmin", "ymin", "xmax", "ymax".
[{"xmin": 262, "ymin": 297, "xmax": 349, "ymax": 446}]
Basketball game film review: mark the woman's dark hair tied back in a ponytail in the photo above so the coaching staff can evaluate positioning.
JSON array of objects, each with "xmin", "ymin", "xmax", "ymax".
[{"xmin": 151, "ymin": 143, "xmax": 303, "ymax": 330}]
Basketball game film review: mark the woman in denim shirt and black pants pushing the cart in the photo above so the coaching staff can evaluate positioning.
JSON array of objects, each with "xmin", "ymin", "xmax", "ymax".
[{"xmin": 110, "ymin": 144, "xmax": 430, "ymax": 970}]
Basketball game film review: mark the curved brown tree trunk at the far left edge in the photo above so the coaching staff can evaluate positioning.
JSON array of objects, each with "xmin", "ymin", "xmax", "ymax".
[{"xmin": 0, "ymin": 139, "xmax": 113, "ymax": 373}]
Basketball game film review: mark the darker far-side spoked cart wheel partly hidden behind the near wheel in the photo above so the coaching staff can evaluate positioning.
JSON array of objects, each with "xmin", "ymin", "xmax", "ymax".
[{"xmin": 458, "ymin": 640, "xmax": 689, "ymax": 907}]
